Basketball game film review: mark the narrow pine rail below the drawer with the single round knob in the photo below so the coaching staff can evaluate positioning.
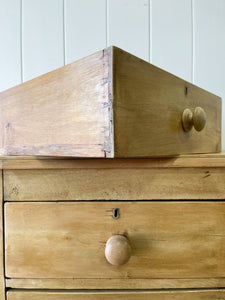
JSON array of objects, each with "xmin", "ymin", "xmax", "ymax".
[{"xmin": 6, "ymin": 278, "xmax": 225, "ymax": 290}]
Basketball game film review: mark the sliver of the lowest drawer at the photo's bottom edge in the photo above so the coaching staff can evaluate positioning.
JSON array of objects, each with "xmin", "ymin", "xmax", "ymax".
[{"xmin": 7, "ymin": 290, "xmax": 225, "ymax": 300}]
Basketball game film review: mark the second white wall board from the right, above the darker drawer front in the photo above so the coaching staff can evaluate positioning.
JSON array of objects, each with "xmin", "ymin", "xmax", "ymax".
[{"xmin": 150, "ymin": 0, "xmax": 192, "ymax": 81}]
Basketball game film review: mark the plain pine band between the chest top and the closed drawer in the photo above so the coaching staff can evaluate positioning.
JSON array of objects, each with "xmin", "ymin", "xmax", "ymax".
[{"xmin": 4, "ymin": 168, "xmax": 225, "ymax": 201}]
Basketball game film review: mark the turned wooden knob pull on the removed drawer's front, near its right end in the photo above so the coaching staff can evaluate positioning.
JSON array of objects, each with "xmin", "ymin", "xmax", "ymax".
[{"xmin": 182, "ymin": 107, "xmax": 206, "ymax": 132}]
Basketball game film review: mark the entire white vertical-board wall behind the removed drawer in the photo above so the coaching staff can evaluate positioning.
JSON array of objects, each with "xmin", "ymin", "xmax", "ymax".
[{"xmin": 0, "ymin": 0, "xmax": 225, "ymax": 149}]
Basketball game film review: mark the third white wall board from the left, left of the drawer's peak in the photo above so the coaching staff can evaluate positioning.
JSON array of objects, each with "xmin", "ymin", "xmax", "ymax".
[{"xmin": 65, "ymin": 0, "xmax": 106, "ymax": 63}]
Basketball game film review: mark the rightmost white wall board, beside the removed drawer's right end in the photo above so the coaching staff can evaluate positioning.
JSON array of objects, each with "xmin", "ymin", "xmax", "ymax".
[{"xmin": 194, "ymin": 0, "xmax": 225, "ymax": 149}]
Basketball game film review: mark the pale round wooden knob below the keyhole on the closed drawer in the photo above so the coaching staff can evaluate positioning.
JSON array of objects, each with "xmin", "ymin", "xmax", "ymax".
[{"xmin": 105, "ymin": 235, "xmax": 131, "ymax": 266}]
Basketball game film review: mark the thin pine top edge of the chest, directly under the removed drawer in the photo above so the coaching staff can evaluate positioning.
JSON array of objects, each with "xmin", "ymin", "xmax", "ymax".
[{"xmin": 0, "ymin": 152, "xmax": 225, "ymax": 170}]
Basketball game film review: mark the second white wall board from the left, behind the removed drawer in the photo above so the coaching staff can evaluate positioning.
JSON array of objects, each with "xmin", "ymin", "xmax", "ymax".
[{"xmin": 22, "ymin": 0, "xmax": 64, "ymax": 81}]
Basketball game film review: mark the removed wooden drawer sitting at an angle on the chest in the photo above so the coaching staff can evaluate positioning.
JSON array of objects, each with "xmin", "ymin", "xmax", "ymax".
[{"xmin": 0, "ymin": 47, "xmax": 221, "ymax": 158}]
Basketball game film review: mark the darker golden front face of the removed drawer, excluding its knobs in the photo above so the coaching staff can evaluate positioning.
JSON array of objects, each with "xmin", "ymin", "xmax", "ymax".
[{"xmin": 113, "ymin": 48, "xmax": 221, "ymax": 157}]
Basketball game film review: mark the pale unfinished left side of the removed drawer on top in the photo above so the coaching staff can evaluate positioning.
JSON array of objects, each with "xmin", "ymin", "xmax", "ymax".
[{"xmin": 0, "ymin": 49, "xmax": 112, "ymax": 157}]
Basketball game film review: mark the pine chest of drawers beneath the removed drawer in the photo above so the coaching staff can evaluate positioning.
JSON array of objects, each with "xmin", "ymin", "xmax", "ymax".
[{"xmin": 0, "ymin": 154, "xmax": 225, "ymax": 300}]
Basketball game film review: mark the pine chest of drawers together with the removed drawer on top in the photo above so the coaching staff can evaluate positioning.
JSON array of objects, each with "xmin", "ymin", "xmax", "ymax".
[{"xmin": 0, "ymin": 47, "xmax": 221, "ymax": 300}]
